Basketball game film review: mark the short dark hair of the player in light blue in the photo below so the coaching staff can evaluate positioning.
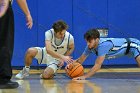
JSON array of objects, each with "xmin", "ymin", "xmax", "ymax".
[{"xmin": 84, "ymin": 29, "xmax": 100, "ymax": 41}]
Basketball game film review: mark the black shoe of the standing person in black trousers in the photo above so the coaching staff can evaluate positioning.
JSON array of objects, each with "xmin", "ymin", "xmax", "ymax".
[{"xmin": 0, "ymin": 81, "xmax": 19, "ymax": 89}]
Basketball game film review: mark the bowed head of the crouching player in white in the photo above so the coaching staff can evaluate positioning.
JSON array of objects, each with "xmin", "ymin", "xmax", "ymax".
[{"xmin": 52, "ymin": 20, "xmax": 68, "ymax": 38}]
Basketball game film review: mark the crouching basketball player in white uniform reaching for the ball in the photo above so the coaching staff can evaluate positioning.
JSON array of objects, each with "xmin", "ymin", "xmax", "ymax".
[{"xmin": 16, "ymin": 20, "xmax": 74, "ymax": 79}]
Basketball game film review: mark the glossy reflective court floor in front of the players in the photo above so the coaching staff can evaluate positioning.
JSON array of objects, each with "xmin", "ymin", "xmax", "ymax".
[{"xmin": 0, "ymin": 72, "xmax": 140, "ymax": 93}]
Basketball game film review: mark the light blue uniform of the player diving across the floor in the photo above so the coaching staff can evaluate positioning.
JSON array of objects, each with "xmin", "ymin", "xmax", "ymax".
[{"xmin": 83, "ymin": 38, "xmax": 140, "ymax": 59}]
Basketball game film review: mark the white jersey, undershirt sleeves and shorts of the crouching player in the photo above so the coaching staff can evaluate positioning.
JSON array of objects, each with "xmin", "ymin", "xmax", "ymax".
[{"xmin": 35, "ymin": 29, "xmax": 74, "ymax": 72}]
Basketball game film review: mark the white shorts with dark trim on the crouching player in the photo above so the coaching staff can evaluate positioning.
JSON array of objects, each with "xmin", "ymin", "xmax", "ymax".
[{"xmin": 35, "ymin": 47, "xmax": 60, "ymax": 73}]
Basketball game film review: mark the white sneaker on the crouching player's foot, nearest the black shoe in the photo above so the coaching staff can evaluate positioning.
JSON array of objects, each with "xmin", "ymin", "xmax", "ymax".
[{"xmin": 15, "ymin": 67, "xmax": 29, "ymax": 79}]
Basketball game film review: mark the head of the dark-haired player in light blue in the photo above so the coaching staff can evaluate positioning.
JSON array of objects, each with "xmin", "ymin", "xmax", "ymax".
[{"xmin": 84, "ymin": 29, "xmax": 100, "ymax": 49}]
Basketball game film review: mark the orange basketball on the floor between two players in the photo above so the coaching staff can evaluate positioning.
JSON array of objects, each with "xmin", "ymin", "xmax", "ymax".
[{"xmin": 65, "ymin": 62, "xmax": 84, "ymax": 78}]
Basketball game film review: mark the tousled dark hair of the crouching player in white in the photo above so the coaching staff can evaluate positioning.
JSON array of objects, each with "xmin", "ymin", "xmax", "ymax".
[{"xmin": 52, "ymin": 20, "xmax": 68, "ymax": 33}]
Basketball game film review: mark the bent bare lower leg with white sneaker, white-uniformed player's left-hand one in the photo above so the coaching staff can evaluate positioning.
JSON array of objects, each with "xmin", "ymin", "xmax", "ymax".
[{"xmin": 15, "ymin": 47, "xmax": 39, "ymax": 79}]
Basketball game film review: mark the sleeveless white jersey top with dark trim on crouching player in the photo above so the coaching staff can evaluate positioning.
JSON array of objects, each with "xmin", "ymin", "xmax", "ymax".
[{"xmin": 46, "ymin": 29, "xmax": 72, "ymax": 55}]
